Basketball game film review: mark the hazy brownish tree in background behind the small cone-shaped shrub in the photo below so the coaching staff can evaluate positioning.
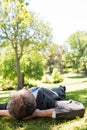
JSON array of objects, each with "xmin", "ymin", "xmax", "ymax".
[{"xmin": 45, "ymin": 44, "xmax": 64, "ymax": 74}]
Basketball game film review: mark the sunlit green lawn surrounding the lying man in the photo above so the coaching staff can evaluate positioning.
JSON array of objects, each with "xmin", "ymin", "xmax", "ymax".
[{"xmin": 0, "ymin": 72, "xmax": 87, "ymax": 130}]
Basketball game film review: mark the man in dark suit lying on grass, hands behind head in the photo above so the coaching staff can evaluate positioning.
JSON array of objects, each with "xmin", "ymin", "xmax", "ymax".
[{"xmin": 0, "ymin": 86, "xmax": 85, "ymax": 120}]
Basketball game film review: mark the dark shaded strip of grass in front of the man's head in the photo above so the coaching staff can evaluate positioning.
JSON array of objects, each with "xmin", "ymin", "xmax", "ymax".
[{"xmin": 0, "ymin": 118, "xmax": 65, "ymax": 130}]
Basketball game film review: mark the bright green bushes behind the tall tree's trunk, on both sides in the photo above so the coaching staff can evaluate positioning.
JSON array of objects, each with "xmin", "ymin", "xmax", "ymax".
[{"xmin": 0, "ymin": 47, "xmax": 44, "ymax": 85}]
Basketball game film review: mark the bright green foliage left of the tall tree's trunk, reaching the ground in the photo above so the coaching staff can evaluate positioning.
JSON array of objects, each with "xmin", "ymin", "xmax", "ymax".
[{"xmin": 0, "ymin": 47, "xmax": 17, "ymax": 90}]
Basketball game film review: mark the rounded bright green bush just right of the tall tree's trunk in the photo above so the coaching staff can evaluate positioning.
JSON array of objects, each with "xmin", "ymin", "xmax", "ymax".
[{"xmin": 24, "ymin": 51, "xmax": 43, "ymax": 80}]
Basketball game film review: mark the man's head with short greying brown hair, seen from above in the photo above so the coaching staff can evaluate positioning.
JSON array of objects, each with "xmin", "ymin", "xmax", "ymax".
[{"xmin": 7, "ymin": 88, "xmax": 36, "ymax": 119}]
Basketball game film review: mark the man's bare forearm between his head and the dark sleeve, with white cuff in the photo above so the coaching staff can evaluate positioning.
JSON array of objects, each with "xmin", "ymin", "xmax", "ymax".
[{"xmin": 24, "ymin": 109, "xmax": 56, "ymax": 120}]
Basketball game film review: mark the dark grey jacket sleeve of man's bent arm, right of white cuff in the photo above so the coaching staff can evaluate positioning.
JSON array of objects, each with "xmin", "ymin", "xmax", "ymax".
[{"xmin": 55, "ymin": 100, "xmax": 85, "ymax": 119}]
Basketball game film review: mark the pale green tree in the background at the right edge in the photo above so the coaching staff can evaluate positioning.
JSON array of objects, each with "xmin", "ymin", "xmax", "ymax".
[{"xmin": 67, "ymin": 31, "xmax": 87, "ymax": 71}]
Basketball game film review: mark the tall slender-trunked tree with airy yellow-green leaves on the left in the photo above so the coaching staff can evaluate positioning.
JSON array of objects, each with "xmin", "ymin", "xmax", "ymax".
[{"xmin": 0, "ymin": 0, "xmax": 52, "ymax": 89}]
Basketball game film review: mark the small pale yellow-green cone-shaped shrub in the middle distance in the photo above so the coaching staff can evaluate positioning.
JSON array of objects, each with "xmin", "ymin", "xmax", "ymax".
[{"xmin": 52, "ymin": 68, "xmax": 63, "ymax": 83}]
